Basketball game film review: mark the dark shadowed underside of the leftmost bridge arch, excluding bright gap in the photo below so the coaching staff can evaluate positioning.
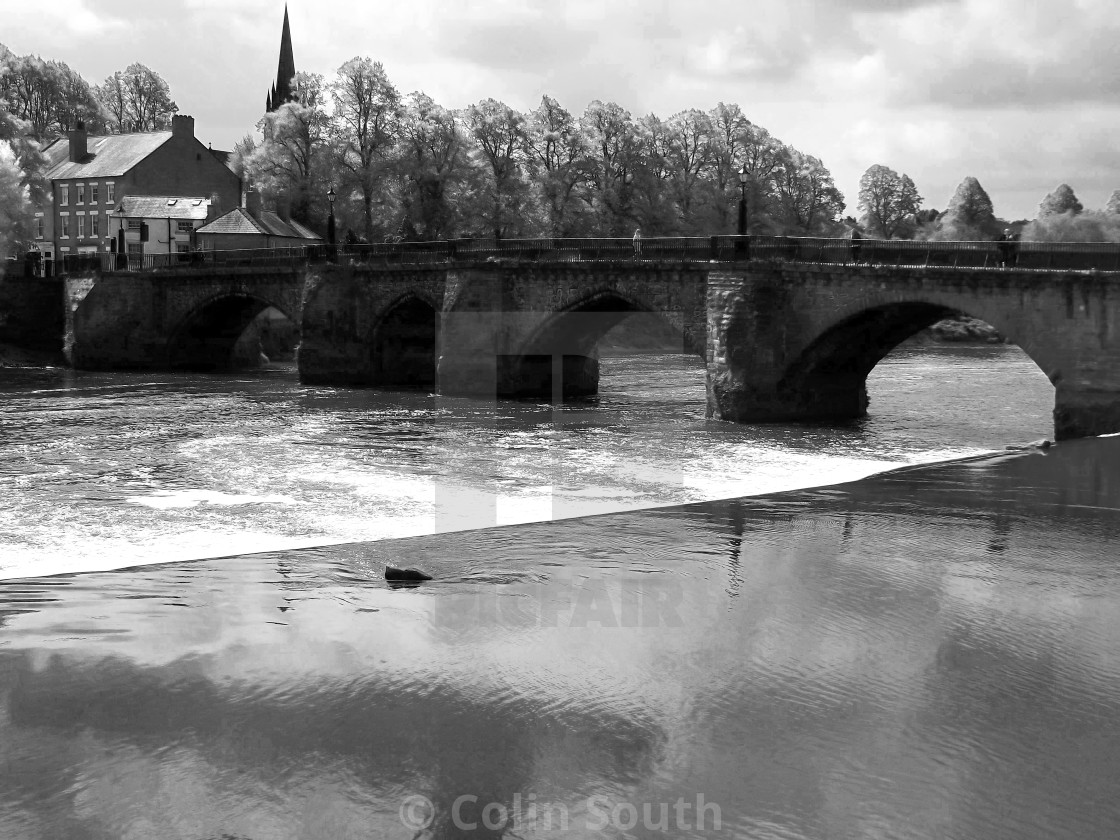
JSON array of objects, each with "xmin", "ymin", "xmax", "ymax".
[{"xmin": 166, "ymin": 291, "xmax": 298, "ymax": 371}]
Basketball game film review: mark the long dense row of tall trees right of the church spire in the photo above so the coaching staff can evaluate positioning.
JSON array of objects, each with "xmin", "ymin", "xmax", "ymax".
[{"xmin": 234, "ymin": 58, "xmax": 844, "ymax": 242}]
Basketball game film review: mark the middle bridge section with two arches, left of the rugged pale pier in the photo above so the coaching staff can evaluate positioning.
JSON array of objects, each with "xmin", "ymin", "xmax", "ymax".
[{"xmin": 299, "ymin": 262, "xmax": 708, "ymax": 399}]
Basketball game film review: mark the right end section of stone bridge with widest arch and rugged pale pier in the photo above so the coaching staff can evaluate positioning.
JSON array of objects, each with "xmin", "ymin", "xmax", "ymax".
[{"xmin": 707, "ymin": 264, "xmax": 1120, "ymax": 439}]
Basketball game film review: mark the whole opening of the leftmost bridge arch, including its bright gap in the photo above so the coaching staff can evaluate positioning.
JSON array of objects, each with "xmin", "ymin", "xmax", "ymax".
[{"xmin": 168, "ymin": 295, "xmax": 298, "ymax": 372}]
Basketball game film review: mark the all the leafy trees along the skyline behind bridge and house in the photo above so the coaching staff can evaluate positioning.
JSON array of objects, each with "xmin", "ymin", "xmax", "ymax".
[{"xmin": 0, "ymin": 44, "xmax": 1120, "ymax": 255}]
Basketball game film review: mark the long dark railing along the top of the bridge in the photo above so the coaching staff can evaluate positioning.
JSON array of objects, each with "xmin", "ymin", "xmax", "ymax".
[{"xmin": 72, "ymin": 235, "xmax": 1120, "ymax": 272}]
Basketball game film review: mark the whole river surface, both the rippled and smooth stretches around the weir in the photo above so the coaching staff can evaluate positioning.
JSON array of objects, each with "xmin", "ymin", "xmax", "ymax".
[{"xmin": 0, "ymin": 346, "xmax": 1120, "ymax": 840}]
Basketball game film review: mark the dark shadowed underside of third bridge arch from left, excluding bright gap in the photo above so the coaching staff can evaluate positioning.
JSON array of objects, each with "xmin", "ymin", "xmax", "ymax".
[{"xmin": 497, "ymin": 288, "xmax": 703, "ymax": 400}]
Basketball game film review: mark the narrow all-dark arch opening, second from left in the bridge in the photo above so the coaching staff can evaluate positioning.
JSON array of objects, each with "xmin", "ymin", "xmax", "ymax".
[{"xmin": 371, "ymin": 297, "xmax": 439, "ymax": 391}]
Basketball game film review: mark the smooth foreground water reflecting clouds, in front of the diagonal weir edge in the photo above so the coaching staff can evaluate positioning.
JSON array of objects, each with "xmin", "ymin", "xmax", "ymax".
[{"xmin": 0, "ymin": 439, "xmax": 1120, "ymax": 840}]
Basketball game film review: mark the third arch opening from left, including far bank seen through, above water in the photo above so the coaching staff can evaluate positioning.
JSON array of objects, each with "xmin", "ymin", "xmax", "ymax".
[{"xmin": 497, "ymin": 293, "xmax": 694, "ymax": 403}]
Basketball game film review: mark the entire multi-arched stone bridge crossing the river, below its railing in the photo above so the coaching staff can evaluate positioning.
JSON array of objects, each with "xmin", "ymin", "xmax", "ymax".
[{"xmin": 68, "ymin": 259, "xmax": 1120, "ymax": 438}]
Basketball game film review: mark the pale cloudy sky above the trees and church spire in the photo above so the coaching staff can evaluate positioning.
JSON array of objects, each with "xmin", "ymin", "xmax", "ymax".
[{"xmin": 0, "ymin": 0, "xmax": 1120, "ymax": 220}]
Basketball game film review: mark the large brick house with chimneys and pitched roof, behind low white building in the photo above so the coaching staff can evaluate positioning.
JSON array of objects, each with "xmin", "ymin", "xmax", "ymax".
[{"xmin": 35, "ymin": 115, "xmax": 241, "ymax": 259}]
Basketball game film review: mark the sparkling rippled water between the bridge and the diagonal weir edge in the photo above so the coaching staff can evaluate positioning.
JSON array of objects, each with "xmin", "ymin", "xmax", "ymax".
[{"xmin": 0, "ymin": 346, "xmax": 1054, "ymax": 577}]
